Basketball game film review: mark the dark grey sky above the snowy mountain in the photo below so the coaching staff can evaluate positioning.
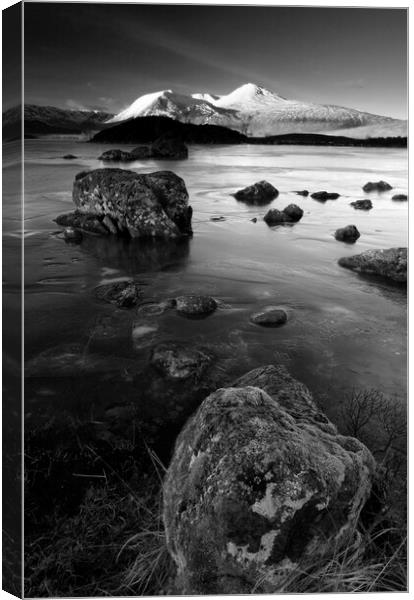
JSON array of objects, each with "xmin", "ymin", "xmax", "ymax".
[{"xmin": 17, "ymin": 3, "xmax": 407, "ymax": 118}]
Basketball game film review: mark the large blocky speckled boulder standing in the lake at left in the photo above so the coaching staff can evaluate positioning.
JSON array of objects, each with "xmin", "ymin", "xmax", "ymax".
[{"xmin": 71, "ymin": 169, "xmax": 192, "ymax": 238}]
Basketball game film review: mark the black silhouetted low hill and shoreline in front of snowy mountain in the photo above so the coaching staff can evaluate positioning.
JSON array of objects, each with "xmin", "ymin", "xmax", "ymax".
[{"xmin": 91, "ymin": 117, "xmax": 407, "ymax": 148}]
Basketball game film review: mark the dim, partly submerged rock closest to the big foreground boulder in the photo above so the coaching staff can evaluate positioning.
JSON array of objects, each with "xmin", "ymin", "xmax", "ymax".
[{"xmin": 151, "ymin": 342, "xmax": 211, "ymax": 379}]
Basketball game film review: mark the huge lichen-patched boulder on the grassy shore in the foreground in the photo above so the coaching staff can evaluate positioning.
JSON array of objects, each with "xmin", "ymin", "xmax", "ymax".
[{"xmin": 164, "ymin": 366, "xmax": 375, "ymax": 595}]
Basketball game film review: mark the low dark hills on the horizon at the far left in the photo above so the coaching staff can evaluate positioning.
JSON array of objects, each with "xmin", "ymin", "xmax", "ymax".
[{"xmin": 3, "ymin": 104, "xmax": 112, "ymax": 141}]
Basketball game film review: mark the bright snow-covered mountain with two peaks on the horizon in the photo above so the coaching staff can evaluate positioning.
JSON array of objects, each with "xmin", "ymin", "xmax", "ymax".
[{"xmin": 108, "ymin": 83, "xmax": 407, "ymax": 137}]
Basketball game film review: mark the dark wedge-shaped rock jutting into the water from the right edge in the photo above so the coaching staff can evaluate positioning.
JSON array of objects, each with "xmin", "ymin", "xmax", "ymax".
[{"xmin": 338, "ymin": 248, "xmax": 407, "ymax": 283}]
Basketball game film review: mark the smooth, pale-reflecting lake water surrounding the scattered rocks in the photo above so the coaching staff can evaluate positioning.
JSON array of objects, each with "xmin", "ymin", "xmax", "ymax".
[{"xmin": 3, "ymin": 140, "xmax": 408, "ymax": 418}]
